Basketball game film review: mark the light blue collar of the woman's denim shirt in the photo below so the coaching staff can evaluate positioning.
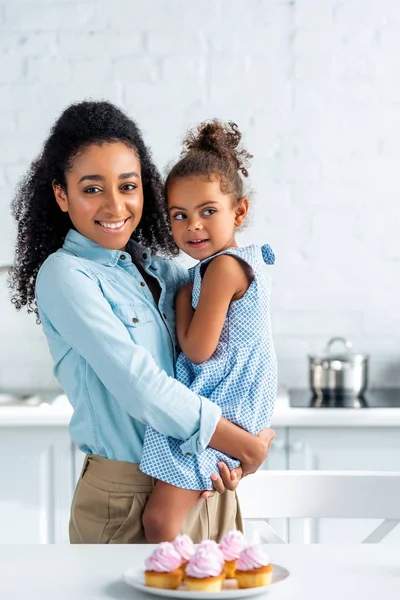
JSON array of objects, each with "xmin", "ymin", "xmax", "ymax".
[{"xmin": 63, "ymin": 229, "xmax": 152, "ymax": 267}]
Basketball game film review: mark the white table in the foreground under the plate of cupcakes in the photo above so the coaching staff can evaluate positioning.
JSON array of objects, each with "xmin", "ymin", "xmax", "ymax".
[{"xmin": 0, "ymin": 545, "xmax": 400, "ymax": 600}]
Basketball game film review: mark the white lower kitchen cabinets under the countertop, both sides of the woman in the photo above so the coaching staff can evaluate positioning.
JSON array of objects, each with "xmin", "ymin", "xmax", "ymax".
[{"xmin": 0, "ymin": 425, "xmax": 400, "ymax": 544}]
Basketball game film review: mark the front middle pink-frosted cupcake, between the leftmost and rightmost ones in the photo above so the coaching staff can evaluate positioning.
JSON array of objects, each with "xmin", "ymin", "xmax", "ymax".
[{"xmin": 185, "ymin": 540, "xmax": 225, "ymax": 592}]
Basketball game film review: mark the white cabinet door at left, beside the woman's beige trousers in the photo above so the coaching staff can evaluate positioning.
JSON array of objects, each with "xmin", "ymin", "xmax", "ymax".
[{"xmin": 0, "ymin": 427, "xmax": 73, "ymax": 544}]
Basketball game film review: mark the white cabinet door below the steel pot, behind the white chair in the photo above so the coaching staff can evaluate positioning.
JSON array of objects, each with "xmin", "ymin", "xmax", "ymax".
[{"xmin": 289, "ymin": 427, "xmax": 400, "ymax": 544}]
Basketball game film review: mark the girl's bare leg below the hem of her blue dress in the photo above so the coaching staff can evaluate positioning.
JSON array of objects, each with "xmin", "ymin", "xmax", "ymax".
[{"xmin": 142, "ymin": 481, "xmax": 201, "ymax": 544}]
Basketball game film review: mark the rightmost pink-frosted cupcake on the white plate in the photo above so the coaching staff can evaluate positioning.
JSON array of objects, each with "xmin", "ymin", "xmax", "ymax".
[{"xmin": 235, "ymin": 544, "xmax": 272, "ymax": 588}]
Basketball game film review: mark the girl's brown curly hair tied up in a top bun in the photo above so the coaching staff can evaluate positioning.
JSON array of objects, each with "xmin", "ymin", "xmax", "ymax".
[{"xmin": 166, "ymin": 119, "xmax": 253, "ymax": 202}]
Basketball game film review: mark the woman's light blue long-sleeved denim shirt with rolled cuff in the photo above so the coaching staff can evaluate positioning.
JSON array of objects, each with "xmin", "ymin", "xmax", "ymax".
[{"xmin": 35, "ymin": 229, "xmax": 221, "ymax": 463}]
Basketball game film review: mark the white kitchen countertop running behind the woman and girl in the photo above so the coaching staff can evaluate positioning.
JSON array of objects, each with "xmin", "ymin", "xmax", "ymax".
[{"xmin": 0, "ymin": 392, "xmax": 400, "ymax": 428}]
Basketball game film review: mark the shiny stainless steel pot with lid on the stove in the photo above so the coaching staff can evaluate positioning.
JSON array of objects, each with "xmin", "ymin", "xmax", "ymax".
[{"xmin": 308, "ymin": 337, "xmax": 369, "ymax": 397}]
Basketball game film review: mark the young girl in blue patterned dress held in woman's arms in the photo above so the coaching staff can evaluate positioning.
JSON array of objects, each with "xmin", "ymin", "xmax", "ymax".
[{"xmin": 140, "ymin": 121, "xmax": 277, "ymax": 542}]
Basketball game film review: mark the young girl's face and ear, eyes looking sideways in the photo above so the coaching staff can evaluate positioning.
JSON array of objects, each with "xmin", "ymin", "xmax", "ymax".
[{"xmin": 168, "ymin": 175, "xmax": 248, "ymax": 260}]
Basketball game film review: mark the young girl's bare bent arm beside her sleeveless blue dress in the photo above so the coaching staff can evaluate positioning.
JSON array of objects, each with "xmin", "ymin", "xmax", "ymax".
[{"xmin": 176, "ymin": 254, "xmax": 252, "ymax": 364}]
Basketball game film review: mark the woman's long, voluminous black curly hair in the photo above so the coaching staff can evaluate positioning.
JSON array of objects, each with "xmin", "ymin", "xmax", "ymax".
[{"xmin": 9, "ymin": 101, "xmax": 177, "ymax": 318}]
